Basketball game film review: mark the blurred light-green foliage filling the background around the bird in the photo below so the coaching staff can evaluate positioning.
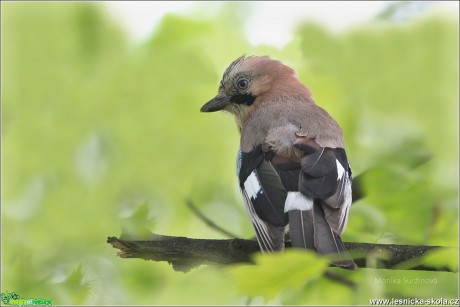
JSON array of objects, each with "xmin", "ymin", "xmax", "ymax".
[{"xmin": 1, "ymin": 2, "xmax": 459, "ymax": 305}]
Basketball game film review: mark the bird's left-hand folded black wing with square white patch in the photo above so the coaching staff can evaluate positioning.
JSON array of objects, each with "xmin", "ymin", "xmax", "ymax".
[{"xmin": 237, "ymin": 145, "xmax": 288, "ymax": 251}]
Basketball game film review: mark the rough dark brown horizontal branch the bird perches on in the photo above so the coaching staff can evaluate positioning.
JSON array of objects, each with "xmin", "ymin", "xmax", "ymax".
[{"xmin": 107, "ymin": 234, "xmax": 450, "ymax": 272}]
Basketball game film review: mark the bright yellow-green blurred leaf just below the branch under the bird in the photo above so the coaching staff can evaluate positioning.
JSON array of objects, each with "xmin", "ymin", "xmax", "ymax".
[{"xmin": 229, "ymin": 249, "xmax": 328, "ymax": 300}]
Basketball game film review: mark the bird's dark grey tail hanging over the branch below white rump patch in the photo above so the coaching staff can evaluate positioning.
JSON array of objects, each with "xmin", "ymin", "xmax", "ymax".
[{"xmin": 289, "ymin": 201, "xmax": 357, "ymax": 270}]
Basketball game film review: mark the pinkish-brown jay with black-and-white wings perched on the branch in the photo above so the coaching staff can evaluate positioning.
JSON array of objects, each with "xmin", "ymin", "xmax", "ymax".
[{"xmin": 200, "ymin": 55, "xmax": 357, "ymax": 270}]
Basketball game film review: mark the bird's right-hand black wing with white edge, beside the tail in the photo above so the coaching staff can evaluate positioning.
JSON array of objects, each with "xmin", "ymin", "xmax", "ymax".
[{"xmin": 293, "ymin": 136, "xmax": 352, "ymax": 235}]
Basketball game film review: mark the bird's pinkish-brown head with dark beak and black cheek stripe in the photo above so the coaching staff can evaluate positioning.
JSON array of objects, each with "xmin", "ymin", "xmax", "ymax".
[{"xmin": 201, "ymin": 56, "xmax": 309, "ymax": 126}]
